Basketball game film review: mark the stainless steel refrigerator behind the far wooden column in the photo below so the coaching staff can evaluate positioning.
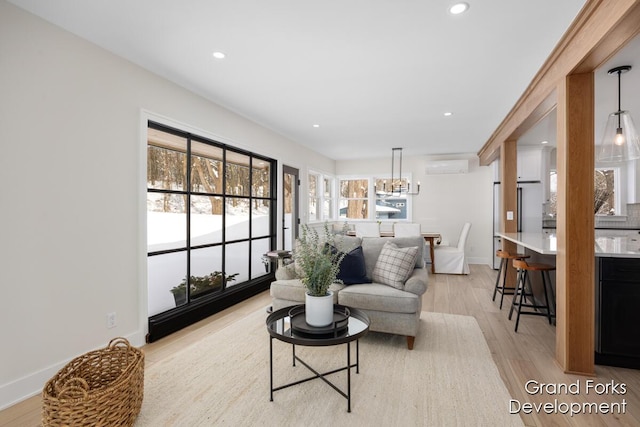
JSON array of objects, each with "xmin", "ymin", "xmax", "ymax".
[{"xmin": 493, "ymin": 181, "xmax": 543, "ymax": 269}]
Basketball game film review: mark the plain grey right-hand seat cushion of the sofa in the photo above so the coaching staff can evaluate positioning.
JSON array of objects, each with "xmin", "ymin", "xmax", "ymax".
[{"xmin": 338, "ymin": 283, "xmax": 421, "ymax": 313}]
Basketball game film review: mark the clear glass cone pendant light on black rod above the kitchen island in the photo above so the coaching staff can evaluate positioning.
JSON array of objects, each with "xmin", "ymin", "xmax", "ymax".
[{"xmin": 596, "ymin": 65, "xmax": 640, "ymax": 162}]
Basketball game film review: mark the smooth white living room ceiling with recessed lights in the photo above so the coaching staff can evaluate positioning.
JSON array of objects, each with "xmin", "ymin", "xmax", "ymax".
[{"xmin": 9, "ymin": 0, "xmax": 585, "ymax": 159}]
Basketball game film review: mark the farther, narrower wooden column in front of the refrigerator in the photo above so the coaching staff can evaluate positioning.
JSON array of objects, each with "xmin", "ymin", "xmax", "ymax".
[{"xmin": 500, "ymin": 141, "xmax": 518, "ymax": 283}]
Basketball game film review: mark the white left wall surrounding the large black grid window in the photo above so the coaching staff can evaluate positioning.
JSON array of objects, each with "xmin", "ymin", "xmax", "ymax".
[{"xmin": 0, "ymin": 1, "xmax": 334, "ymax": 409}]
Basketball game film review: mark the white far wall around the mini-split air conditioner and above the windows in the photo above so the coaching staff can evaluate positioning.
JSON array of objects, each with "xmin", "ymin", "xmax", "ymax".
[{"xmin": 336, "ymin": 154, "xmax": 493, "ymax": 265}]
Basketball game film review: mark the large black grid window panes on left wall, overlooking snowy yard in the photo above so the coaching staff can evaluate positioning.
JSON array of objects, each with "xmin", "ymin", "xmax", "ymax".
[{"xmin": 147, "ymin": 122, "xmax": 276, "ymax": 316}]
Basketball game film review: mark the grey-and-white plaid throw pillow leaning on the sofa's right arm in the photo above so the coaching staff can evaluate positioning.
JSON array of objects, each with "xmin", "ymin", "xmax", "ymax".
[{"xmin": 372, "ymin": 242, "xmax": 418, "ymax": 289}]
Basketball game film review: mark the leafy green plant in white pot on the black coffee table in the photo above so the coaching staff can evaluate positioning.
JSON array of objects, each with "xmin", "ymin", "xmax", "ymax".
[{"xmin": 293, "ymin": 223, "xmax": 345, "ymax": 326}]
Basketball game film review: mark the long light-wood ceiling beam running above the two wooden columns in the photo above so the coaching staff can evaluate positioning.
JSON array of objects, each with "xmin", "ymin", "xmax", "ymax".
[{"xmin": 478, "ymin": 0, "xmax": 640, "ymax": 166}]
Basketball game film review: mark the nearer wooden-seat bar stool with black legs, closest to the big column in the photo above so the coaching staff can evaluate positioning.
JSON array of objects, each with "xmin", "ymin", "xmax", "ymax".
[{"xmin": 509, "ymin": 259, "xmax": 556, "ymax": 332}]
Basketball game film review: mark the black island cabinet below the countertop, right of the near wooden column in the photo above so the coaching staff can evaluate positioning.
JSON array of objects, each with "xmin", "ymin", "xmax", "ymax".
[{"xmin": 595, "ymin": 257, "xmax": 640, "ymax": 369}]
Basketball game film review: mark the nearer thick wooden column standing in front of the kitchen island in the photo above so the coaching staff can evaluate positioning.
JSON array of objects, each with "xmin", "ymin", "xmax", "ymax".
[{"xmin": 556, "ymin": 72, "xmax": 595, "ymax": 375}]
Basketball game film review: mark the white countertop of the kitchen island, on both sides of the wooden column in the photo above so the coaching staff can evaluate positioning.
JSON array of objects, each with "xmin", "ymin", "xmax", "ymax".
[{"xmin": 496, "ymin": 230, "xmax": 640, "ymax": 258}]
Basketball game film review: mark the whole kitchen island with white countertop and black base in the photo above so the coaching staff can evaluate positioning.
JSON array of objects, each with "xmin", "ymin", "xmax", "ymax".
[{"xmin": 497, "ymin": 230, "xmax": 640, "ymax": 369}]
